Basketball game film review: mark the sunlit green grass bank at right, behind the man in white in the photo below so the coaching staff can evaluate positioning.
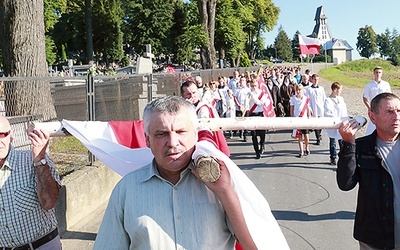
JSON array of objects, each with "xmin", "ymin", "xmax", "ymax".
[{"xmin": 319, "ymin": 59, "xmax": 400, "ymax": 88}]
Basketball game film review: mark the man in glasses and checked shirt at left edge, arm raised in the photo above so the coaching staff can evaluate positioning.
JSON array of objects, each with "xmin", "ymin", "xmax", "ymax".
[{"xmin": 0, "ymin": 116, "xmax": 61, "ymax": 250}]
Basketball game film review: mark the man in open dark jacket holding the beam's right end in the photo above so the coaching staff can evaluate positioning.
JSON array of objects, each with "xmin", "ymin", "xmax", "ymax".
[{"xmin": 336, "ymin": 93, "xmax": 400, "ymax": 250}]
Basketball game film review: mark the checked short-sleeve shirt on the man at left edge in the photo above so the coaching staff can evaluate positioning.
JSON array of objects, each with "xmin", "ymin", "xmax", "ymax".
[{"xmin": 0, "ymin": 148, "xmax": 61, "ymax": 247}]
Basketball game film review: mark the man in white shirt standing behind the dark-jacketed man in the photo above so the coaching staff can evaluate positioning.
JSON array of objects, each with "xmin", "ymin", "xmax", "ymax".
[{"xmin": 363, "ymin": 67, "xmax": 392, "ymax": 135}]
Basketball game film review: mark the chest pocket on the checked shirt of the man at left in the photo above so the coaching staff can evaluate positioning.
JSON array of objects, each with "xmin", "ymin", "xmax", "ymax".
[{"xmin": 13, "ymin": 187, "xmax": 39, "ymax": 213}]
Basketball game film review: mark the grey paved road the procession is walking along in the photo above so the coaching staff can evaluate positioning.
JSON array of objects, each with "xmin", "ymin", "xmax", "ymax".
[{"xmin": 62, "ymin": 131, "xmax": 358, "ymax": 250}]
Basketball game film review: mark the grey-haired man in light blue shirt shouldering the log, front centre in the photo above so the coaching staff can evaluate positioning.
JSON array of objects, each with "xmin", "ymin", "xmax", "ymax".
[{"xmin": 94, "ymin": 96, "xmax": 256, "ymax": 250}]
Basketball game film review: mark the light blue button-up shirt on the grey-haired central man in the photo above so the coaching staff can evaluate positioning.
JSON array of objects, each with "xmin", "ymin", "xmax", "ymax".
[{"xmin": 94, "ymin": 161, "xmax": 235, "ymax": 250}]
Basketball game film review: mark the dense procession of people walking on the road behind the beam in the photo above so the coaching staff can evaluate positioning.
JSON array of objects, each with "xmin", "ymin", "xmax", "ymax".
[{"xmin": 182, "ymin": 66, "xmax": 347, "ymax": 165}]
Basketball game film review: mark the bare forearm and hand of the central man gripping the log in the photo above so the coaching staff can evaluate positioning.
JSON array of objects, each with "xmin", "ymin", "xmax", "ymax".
[{"xmin": 192, "ymin": 160, "xmax": 257, "ymax": 249}]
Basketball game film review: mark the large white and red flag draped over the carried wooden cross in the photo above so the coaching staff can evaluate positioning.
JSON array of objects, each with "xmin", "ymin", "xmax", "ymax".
[{"xmin": 61, "ymin": 120, "xmax": 289, "ymax": 250}]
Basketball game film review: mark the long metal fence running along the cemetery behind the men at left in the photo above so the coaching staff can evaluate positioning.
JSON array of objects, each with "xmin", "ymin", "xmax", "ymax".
[{"xmin": 0, "ymin": 67, "xmax": 258, "ymax": 141}]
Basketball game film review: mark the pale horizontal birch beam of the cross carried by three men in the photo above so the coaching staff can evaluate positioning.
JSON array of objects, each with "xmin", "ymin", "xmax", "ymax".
[{"xmin": 33, "ymin": 116, "xmax": 367, "ymax": 137}]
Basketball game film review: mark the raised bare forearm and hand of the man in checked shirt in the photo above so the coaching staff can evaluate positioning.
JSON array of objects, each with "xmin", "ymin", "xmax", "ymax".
[{"xmin": 28, "ymin": 128, "xmax": 60, "ymax": 210}]
